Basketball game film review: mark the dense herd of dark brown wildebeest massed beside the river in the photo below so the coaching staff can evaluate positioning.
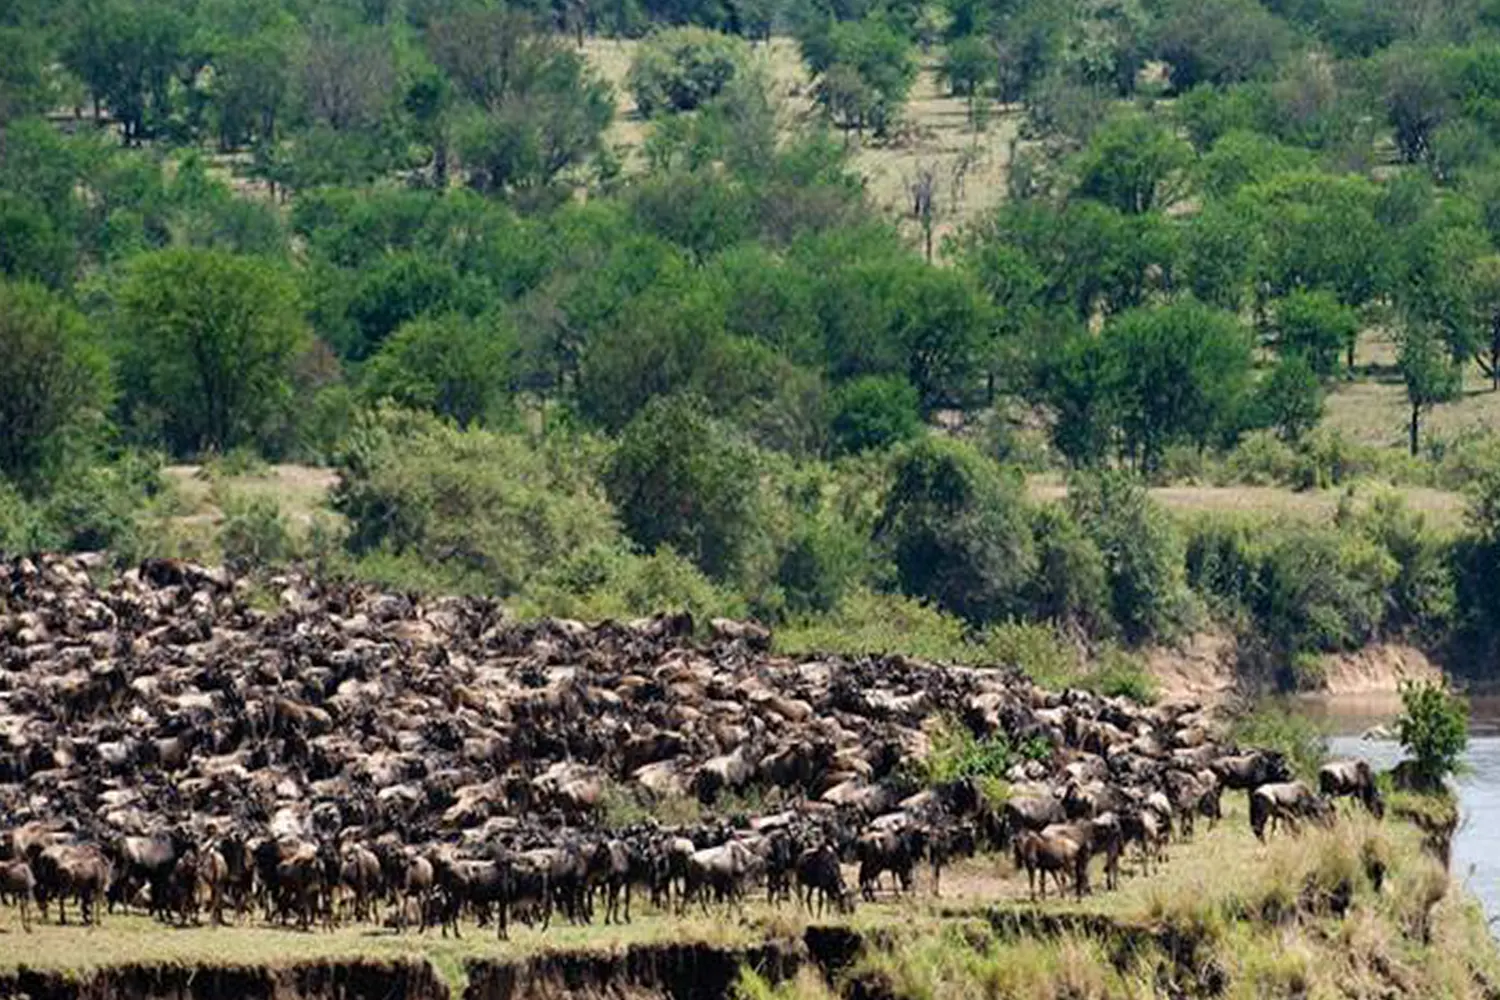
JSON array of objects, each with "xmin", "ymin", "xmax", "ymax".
[{"xmin": 0, "ymin": 556, "xmax": 1382, "ymax": 937}]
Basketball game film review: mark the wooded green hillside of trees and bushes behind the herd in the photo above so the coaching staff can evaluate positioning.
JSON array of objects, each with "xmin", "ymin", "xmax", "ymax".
[{"xmin": 11, "ymin": 0, "xmax": 1500, "ymax": 697}]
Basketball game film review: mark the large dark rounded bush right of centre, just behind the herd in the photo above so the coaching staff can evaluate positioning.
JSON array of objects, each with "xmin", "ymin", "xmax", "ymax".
[{"xmin": 876, "ymin": 438, "xmax": 1037, "ymax": 622}]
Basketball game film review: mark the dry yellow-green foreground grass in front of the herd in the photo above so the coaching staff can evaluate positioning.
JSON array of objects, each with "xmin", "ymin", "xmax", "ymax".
[{"xmin": 0, "ymin": 793, "xmax": 1482, "ymax": 1000}]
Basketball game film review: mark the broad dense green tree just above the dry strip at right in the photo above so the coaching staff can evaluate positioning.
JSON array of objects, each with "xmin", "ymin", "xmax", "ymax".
[{"xmin": 1104, "ymin": 300, "xmax": 1253, "ymax": 471}]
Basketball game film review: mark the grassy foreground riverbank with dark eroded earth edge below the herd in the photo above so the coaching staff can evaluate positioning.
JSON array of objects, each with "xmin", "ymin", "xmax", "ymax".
[{"xmin": 0, "ymin": 793, "xmax": 1500, "ymax": 1000}]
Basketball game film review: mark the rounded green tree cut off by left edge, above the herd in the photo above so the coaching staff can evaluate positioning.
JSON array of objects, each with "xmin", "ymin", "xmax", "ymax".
[{"xmin": 0, "ymin": 282, "xmax": 108, "ymax": 487}]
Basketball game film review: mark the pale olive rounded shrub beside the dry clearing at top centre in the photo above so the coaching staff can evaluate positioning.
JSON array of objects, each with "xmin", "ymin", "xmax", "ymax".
[{"xmin": 626, "ymin": 27, "xmax": 749, "ymax": 117}]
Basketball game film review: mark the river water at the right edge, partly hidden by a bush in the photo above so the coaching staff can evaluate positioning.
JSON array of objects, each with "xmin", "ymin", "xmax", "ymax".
[{"xmin": 1305, "ymin": 696, "xmax": 1500, "ymax": 919}]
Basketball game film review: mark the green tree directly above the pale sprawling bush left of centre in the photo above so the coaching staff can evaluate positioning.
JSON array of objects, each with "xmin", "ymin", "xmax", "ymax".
[{"xmin": 362, "ymin": 313, "xmax": 518, "ymax": 427}]
